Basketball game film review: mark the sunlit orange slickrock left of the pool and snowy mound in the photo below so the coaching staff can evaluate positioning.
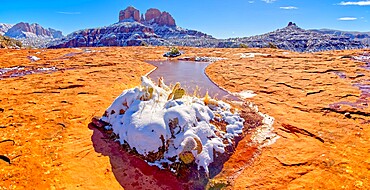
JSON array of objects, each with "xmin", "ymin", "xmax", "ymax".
[{"xmin": 0, "ymin": 48, "xmax": 160, "ymax": 189}]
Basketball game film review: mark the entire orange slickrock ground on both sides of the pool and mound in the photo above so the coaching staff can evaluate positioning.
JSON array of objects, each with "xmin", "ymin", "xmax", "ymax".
[{"xmin": 0, "ymin": 47, "xmax": 370, "ymax": 189}]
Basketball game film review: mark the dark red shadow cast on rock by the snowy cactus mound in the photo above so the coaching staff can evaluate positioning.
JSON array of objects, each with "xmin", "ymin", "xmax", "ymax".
[{"xmin": 89, "ymin": 123, "xmax": 208, "ymax": 190}]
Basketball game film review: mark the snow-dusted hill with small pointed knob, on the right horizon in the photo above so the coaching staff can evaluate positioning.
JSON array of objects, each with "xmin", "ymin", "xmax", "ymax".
[{"xmin": 223, "ymin": 22, "xmax": 367, "ymax": 52}]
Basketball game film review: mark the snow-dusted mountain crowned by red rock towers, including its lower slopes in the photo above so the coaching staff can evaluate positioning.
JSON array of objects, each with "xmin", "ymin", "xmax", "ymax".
[{"xmin": 48, "ymin": 6, "xmax": 214, "ymax": 48}]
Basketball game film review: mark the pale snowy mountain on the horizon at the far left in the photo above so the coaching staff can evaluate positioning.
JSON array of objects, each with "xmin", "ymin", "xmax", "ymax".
[{"xmin": 0, "ymin": 22, "xmax": 63, "ymax": 48}]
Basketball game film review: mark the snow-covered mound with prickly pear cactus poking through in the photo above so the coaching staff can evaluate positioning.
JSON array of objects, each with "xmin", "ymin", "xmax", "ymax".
[{"xmin": 93, "ymin": 77, "xmax": 276, "ymax": 175}]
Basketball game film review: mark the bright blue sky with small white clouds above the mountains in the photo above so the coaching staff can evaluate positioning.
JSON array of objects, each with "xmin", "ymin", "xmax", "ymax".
[{"xmin": 0, "ymin": 0, "xmax": 370, "ymax": 38}]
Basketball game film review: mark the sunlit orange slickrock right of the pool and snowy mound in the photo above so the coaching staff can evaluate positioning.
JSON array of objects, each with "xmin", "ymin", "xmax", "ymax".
[{"xmin": 206, "ymin": 49, "xmax": 370, "ymax": 189}]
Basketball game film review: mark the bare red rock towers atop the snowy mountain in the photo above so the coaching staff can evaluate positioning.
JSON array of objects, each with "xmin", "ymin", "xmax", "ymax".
[{"xmin": 119, "ymin": 6, "xmax": 176, "ymax": 27}]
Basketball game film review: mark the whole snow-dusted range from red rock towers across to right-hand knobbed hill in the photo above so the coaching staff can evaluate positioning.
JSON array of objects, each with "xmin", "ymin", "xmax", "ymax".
[{"xmin": 48, "ymin": 6, "xmax": 369, "ymax": 52}]
